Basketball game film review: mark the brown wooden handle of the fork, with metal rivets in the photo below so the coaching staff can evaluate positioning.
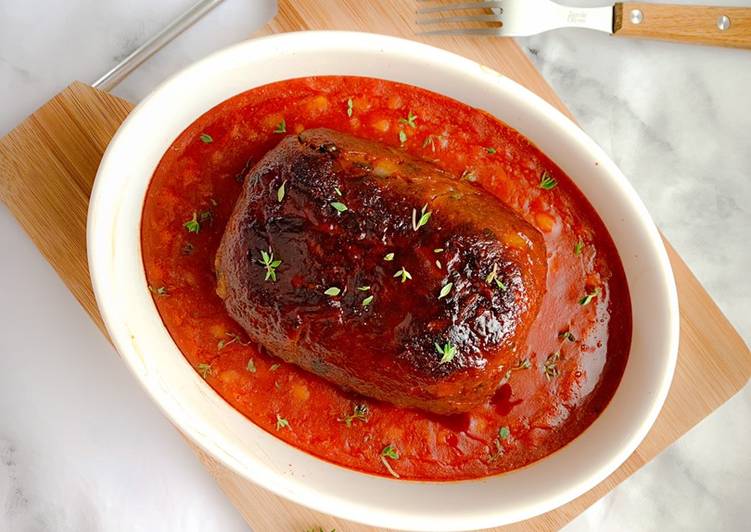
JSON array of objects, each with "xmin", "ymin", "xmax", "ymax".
[{"xmin": 613, "ymin": 2, "xmax": 751, "ymax": 49}]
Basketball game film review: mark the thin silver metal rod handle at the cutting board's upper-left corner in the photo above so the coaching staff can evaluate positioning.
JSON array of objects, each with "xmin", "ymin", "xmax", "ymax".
[{"xmin": 92, "ymin": 0, "xmax": 222, "ymax": 91}]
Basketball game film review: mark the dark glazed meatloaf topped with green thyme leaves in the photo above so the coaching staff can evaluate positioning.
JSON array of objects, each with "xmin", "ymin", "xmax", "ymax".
[{"xmin": 216, "ymin": 129, "xmax": 547, "ymax": 414}]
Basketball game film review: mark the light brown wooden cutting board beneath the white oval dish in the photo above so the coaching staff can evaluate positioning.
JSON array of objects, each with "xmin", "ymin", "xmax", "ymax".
[{"xmin": 0, "ymin": 0, "xmax": 751, "ymax": 532}]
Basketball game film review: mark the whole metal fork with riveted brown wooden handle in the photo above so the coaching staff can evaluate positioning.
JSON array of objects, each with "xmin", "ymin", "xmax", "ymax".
[{"xmin": 416, "ymin": 0, "xmax": 751, "ymax": 49}]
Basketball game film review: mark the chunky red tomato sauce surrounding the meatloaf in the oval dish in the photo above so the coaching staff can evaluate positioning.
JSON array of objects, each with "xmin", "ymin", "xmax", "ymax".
[{"xmin": 141, "ymin": 76, "xmax": 631, "ymax": 480}]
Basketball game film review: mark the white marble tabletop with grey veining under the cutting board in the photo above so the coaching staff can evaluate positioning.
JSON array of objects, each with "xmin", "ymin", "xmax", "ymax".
[{"xmin": 0, "ymin": 0, "xmax": 751, "ymax": 532}]
